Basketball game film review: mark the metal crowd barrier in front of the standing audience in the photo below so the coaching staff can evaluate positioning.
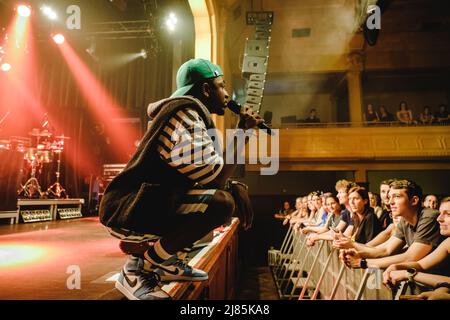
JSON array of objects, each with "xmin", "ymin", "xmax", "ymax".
[{"xmin": 269, "ymin": 227, "xmax": 393, "ymax": 300}]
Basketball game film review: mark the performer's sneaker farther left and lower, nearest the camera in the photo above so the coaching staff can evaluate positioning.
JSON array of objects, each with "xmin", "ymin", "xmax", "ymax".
[{"xmin": 116, "ymin": 257, "xmax": 171, "ymax": 300}]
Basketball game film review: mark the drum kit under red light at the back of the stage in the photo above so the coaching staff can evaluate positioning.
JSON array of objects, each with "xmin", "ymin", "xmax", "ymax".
[{"xmin": 0, "ymin": 129, "xmax": 70, "ymax": 198}]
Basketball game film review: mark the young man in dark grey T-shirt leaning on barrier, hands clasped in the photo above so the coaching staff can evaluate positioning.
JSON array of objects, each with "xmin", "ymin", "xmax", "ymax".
[{"xmin": 341, "ymin": 180, "xmax": 442, "ymax": 268}]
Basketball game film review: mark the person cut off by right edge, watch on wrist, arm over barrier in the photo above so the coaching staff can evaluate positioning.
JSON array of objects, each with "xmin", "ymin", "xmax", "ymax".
[{"xmin": 383, "ymin": 197, "xmax": 450, "ymax": 299}]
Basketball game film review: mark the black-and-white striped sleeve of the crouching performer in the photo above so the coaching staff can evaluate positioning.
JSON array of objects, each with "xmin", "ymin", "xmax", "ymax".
[{"xmin": 157, "ymin": 109, "xmax": 224, "ymax": 185}]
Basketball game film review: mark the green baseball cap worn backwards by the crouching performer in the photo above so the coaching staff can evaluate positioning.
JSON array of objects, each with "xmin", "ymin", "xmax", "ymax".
[{"xmin": 170, "ymin": 59, "xmax": 223, "ymax": 97}]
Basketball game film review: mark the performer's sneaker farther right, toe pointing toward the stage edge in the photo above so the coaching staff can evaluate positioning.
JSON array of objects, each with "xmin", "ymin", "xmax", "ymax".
[{"xmin": 144, "ymin": 253, "xmax": 208, "ymax": 281}]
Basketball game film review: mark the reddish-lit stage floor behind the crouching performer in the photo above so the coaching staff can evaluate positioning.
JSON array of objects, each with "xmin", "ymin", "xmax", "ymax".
[{"xmin": 0, "ymin": 217, "xmax": 126, "ymax": 300}]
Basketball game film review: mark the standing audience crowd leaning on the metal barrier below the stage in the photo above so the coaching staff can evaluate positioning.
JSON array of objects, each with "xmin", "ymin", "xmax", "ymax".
[{"xmin": 283, "ymin": 179, "xmax": 450, "ymax": 299}]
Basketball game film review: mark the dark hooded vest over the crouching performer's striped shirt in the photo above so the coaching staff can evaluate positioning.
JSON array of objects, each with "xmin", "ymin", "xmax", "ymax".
[{"xmin": 99, "ymin": 96, "xmax": 214, "ymax": 235}]
